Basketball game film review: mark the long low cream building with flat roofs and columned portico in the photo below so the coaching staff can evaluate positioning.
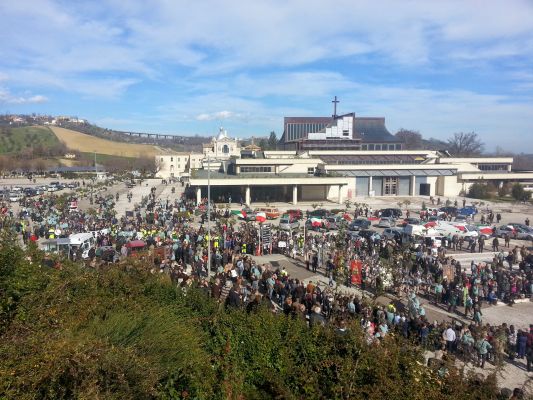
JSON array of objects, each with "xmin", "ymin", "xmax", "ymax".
[{"xmin": 186, "ymin": 150, "xmax": 533, "ymax": 204}]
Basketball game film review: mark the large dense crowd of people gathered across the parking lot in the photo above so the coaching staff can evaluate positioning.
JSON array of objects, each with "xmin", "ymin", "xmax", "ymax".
[{"xmin": 0, "ymin": 181, "xmax": 533, "ymax": 378}]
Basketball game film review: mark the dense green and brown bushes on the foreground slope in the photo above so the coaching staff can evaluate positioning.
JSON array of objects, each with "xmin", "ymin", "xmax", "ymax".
[{"xmin": 0, "ymin": 234, "xmax": 512, "ymax": 400}]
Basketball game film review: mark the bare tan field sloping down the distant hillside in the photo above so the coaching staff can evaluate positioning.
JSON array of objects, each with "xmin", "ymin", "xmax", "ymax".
[{"xmin": 50, "ymin": 127, "xmax": 167, "ymax": 158}]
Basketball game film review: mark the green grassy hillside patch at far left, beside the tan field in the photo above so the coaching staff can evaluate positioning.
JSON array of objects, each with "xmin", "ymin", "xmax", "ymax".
[{"xmin": 0, "ymin": 126, "xmax": 59, "ymax": 154}]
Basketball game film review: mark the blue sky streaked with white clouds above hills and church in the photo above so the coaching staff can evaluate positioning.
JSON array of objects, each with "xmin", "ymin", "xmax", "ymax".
[{"xmin": 0, "ymin": 0, "xmax": 533, "ymax": 152}]
